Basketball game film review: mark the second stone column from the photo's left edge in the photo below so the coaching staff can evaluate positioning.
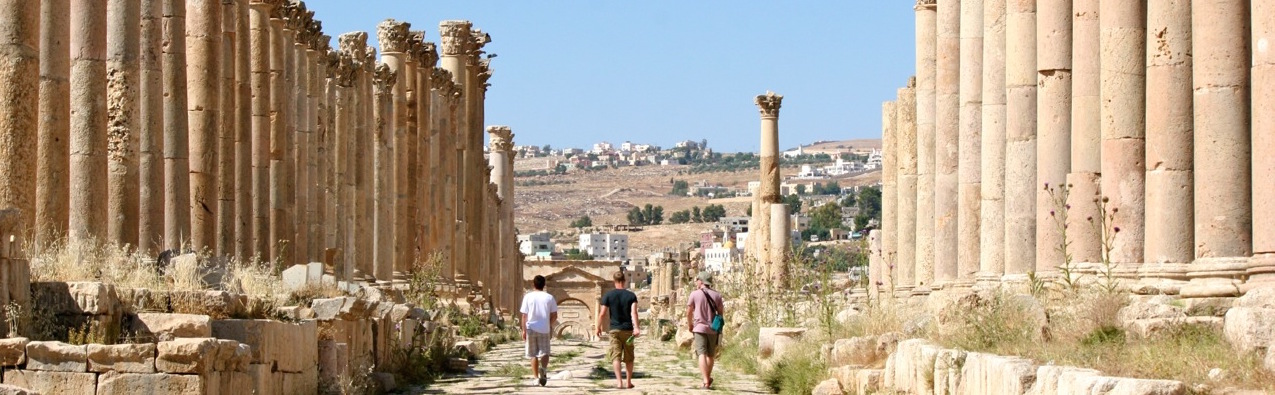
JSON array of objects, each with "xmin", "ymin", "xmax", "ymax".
[{"xmin": 35, "ymin": 0, "xmax": 68, "ymax": 246}]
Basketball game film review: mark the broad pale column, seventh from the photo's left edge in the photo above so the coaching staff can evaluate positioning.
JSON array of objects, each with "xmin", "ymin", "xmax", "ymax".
[{"xmin": 186, "ymin": 0, "xmax": 222, "ymax": 251}]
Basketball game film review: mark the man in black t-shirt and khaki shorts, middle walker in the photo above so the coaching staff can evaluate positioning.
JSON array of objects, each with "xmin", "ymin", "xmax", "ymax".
[{"xmin": 597, "ymin": 271, "xmax": 641, "ymax": 389}]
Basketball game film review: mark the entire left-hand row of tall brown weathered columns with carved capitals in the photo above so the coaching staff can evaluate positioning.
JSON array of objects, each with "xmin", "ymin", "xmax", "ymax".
[{"xmin": 0, "ymin": 0, "xmax": 523, "ymax": 311}]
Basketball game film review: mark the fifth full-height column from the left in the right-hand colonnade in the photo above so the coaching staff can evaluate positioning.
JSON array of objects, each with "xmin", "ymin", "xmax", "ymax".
[{"xmin": 1003, "ymin": 0, "xmax": 1038, "ymax": 283}]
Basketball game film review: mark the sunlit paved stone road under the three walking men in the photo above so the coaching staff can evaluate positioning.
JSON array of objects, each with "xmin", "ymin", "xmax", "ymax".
[{"xmin": 412, "ymin": 338, "xmax": 769, "ymax": 395}]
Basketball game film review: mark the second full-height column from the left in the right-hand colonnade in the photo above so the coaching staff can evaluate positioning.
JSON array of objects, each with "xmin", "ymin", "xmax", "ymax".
[{"xmin": 933, "ymin": 0, "xmax": 960, "ymax": 287}]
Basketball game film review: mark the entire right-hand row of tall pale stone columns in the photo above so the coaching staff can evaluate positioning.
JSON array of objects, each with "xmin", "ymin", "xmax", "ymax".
[{"xmin": 872, "ymin": 0, "xmax": 1275, "ymax": 297}]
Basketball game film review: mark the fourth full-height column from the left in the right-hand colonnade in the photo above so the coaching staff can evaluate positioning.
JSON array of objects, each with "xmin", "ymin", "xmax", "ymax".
[{"xmin": 974, "ymin": 0, "xmax": 1005, "ymax": 287}]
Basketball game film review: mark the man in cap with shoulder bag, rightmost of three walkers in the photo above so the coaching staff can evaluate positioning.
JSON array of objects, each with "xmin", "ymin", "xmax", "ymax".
[{"xmin": 686, "ymin": 270, "xmax": 725, "ymax": 389}]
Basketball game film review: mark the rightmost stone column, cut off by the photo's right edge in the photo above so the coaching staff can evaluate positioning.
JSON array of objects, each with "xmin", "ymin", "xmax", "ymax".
[{"xmin": 1247, "ymin": 0, "xmax": 1275, "ymax": 284}]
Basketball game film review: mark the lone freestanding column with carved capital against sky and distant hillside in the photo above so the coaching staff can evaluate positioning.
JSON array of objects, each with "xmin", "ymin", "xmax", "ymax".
[{"xmin": 748, "ymin": 90, "xmax": 788, "ymax": 287}]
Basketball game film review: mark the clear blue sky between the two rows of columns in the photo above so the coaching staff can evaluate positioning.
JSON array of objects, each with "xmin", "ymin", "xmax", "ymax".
[{"xmin": 306, "ymin": 0, "xmax": 914, "ymax": 152}]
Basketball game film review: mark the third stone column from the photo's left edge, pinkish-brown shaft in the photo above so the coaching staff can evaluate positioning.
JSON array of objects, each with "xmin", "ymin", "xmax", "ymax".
[{"xmin": 68, "ymin": 0, "xmax": 107, "ymax": 241}]
